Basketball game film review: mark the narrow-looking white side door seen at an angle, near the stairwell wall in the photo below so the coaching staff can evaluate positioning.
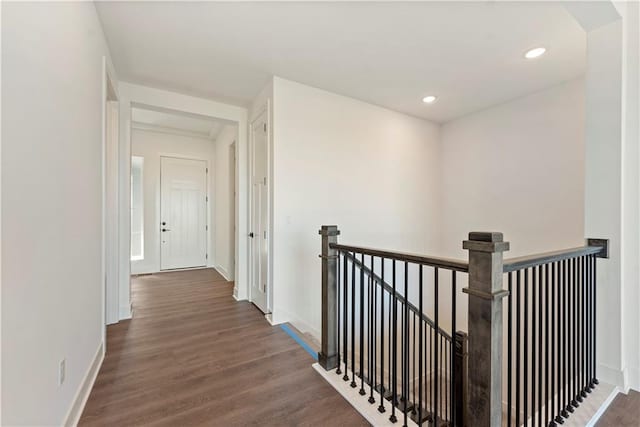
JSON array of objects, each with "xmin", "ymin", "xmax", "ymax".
[{"xmin": 249, "ymin": 113, "xmax": 269, "ymax": 313}]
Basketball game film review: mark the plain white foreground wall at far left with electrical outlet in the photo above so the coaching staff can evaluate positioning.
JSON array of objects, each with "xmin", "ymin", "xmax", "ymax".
[{"xmin": 1, "ymin": 3, "xmax": 114, "ymax": 425}]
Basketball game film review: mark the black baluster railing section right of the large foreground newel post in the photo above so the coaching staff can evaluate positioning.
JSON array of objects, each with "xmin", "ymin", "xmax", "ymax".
[{"xmin": 504, "ymin": 246, "xmax": 605, "ymax": 427}]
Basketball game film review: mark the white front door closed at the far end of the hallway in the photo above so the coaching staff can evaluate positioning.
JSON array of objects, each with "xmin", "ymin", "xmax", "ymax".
[{"xmin": 159, "ymin": 157, "xmax": 207, "ymax": 270}]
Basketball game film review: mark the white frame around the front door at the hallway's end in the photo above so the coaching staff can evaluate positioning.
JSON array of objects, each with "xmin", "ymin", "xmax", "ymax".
[{"xmin": 156, "ymin": 154, "xmax": 214, "ymax": 273}]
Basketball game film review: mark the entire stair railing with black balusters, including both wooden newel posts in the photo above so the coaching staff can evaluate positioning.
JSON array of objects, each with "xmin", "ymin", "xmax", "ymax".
[{"xmin": 318, "ymin": 226, "xmax": 608, "ymax": 427}]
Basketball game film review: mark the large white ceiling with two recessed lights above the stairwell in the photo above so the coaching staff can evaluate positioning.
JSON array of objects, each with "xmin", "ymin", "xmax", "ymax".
[{"xmin": 97, "ymin": 2, "xmax": 586, "ymax": 122}]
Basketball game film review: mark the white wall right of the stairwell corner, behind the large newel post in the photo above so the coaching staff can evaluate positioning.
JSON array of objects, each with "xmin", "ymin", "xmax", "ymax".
[{"xmin": 439, "ymin": 79, "xmax": 584, "ymax": 259}]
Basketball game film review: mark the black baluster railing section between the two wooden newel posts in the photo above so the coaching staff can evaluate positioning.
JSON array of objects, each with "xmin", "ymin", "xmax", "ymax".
[{"xmin": 331, "ymin": 244, "xmax": 466, "ymax": 427}]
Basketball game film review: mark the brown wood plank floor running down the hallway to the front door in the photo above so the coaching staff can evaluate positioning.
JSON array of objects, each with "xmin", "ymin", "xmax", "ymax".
[{"xmin": 80, "ymin": 269, "xmax": 367, "ymax": 426}]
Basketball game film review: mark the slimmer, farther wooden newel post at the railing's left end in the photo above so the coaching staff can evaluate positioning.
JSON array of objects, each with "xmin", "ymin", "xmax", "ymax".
[{"xmin": 318, "ymin": 225, "xmax": 340, "ymax": 371}]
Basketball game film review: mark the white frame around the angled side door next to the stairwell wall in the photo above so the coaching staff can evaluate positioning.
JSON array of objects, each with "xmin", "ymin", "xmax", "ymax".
[{"xmin": 247, "ymin": 109, "xmax": 273, "ymax": 315}]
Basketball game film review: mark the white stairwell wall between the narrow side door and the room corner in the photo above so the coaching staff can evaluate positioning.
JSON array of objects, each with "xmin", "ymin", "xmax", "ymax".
[{"xmin": 272, "ymin": 78, "xmax": 439, "ymax": 337}]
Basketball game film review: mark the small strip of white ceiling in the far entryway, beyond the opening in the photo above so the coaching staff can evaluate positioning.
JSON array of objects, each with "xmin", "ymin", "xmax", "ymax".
[{"xmin": 131, "ymin": 107, "xmax": 224, "ymax": 139}]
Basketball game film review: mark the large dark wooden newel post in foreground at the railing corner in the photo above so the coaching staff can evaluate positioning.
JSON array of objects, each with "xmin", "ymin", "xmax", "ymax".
[{"xmin": 462, "ymin": 232, "xmax": 509, "ymax": 427}]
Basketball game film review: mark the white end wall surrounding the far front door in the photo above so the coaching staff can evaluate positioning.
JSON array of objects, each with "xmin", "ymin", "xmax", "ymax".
[{"xmin": 131, "ymin": 128, "xmax": 215, "ymax": 274}]
